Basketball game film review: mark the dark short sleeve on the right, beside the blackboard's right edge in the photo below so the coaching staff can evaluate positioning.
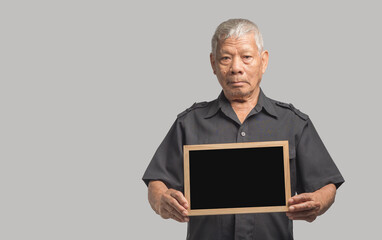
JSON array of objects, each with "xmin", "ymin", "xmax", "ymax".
[{"xmin": 296, "ymin": 119, "xmax": 344, "ymax": 193}]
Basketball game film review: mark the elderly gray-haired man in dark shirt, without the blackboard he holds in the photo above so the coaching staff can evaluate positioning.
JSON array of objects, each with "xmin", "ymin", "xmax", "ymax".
[{"xmin": 143, "ymin": 19, "xmax": 344, "ymax": 240}]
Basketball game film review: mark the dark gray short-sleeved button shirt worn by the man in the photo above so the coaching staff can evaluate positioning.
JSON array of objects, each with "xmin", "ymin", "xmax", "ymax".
[{"xmin": 143, "ymin": 90, "xmax": 344, "ymax": 240}]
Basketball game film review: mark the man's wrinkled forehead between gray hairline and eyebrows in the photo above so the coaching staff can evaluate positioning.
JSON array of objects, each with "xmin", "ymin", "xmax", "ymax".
[{"xmin": 217, "ymin": 33, "xmax": 257, "ymax": 52}]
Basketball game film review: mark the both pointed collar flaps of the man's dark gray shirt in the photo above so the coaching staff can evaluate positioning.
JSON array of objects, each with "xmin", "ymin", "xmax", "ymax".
[{"xmin": 205, "ymin": 88, "xmax": 278, "ymax": 118}]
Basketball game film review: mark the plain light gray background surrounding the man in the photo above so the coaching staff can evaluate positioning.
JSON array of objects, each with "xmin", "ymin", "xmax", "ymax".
[{"xmin": 0, "ymin": 0, "xmax": 382, "ymax": 240}]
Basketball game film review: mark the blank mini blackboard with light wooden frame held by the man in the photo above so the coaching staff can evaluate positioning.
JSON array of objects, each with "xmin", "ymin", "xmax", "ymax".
[{"xmin": 184, "ymin": 141, "xmax": 291, "ymax": 216}]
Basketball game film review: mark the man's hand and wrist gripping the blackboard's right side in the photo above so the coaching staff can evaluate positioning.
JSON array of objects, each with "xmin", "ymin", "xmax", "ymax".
[{"xmin": 286, "ymin": 184, "xmax": 336, "ymax": 222}]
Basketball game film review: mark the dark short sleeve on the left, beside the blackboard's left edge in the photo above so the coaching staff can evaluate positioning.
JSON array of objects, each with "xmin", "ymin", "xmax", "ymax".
[{"xmin": 142, "ymin": 119, "xmax": 184, "ymax": 190}]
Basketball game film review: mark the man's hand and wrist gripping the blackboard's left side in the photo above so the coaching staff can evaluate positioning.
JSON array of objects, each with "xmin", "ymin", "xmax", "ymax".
[{"xmin": 149, "ymin": 181, "xmax": 189, "ymax": 222}]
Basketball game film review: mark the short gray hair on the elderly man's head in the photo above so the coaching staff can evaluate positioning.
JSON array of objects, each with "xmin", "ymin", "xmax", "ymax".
[{"xmin": 211, "ymin": 18, "xmax": 264, "ymax": 56}]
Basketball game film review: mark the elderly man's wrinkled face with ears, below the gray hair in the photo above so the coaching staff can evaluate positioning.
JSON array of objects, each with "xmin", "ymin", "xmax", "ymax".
[{"xmin": 210, "ymin": 33, "xmax": 268, "ymax": 100}]
